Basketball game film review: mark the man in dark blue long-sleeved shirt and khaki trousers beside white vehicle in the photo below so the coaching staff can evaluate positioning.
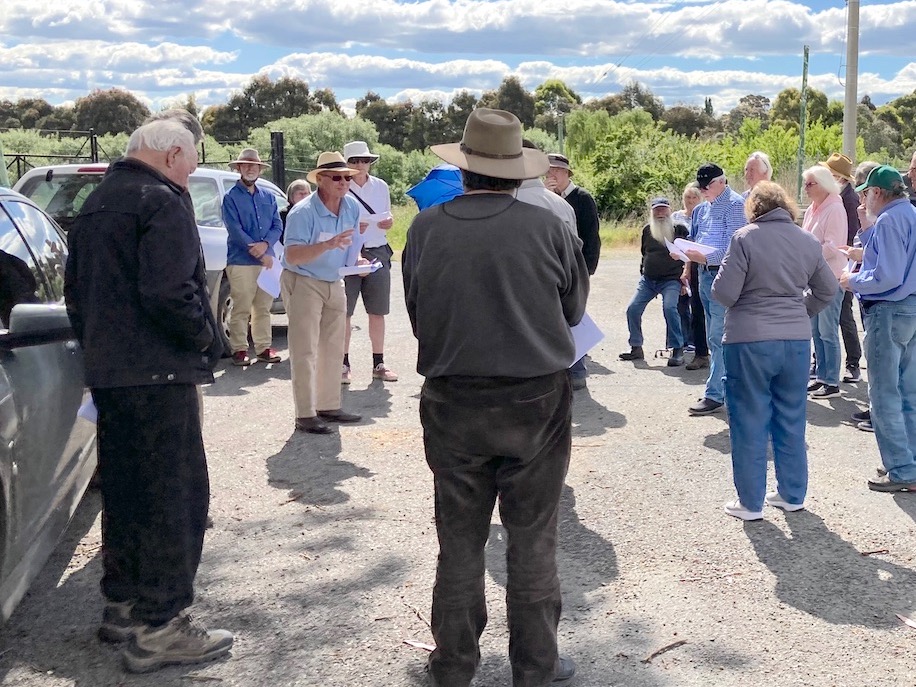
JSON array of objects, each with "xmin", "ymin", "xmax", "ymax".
[{"xmin": 223, "ymin": 148, "xmax": 283, "ymax": 365}]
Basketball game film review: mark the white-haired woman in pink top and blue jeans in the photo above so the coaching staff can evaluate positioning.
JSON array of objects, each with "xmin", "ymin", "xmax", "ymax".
[{"xmin": 802, "ymin": 165, "xmax": 847, "ymax": 398}]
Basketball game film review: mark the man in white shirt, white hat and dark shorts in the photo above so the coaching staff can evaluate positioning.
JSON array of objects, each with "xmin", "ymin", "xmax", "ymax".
[{"xmin": 340, "ymin": 141, "xmax": 398, "ymax": 384}]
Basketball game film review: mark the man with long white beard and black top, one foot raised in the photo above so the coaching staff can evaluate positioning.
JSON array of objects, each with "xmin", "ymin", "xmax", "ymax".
[{"xmin": 620, "ymin": 198, "xmax": 688, "ymax": 367}]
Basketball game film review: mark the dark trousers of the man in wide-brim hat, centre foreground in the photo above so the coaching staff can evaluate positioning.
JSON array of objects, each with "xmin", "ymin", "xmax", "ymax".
[{"xmin": 420, "ymin": 370, "xmax": 572, "ymax": 687}]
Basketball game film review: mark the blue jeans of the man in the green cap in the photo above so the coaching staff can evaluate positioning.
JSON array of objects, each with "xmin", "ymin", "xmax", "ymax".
[{"xmin": 865, "ymin": 294, "xmax": 916, "ymax": 482}]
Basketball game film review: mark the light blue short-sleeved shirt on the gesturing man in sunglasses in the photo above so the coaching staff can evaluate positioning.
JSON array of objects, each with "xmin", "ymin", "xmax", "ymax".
[{"xmin": 282, "ymin": 191, "xmax": 359, "ymax": 282}]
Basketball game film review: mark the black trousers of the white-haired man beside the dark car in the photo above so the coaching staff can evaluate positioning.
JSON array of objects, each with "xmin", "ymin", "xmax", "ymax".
[{"xmin": 92, "ymin": 384, "xmax": 210, "ymax": 625}]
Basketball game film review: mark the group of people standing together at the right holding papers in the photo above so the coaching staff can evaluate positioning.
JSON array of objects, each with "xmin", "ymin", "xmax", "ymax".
[{"xmin": 619, "ymin": 151, "xmax": 916, "ymax": 520}]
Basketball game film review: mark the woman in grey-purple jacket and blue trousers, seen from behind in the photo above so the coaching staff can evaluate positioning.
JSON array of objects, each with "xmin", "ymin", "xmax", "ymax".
[{"xmin": 712, "ymin": 181, "xmax": 838, "ymax": 520}]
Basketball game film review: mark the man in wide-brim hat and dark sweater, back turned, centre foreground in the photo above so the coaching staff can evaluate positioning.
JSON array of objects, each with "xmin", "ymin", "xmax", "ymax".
[{"xmin": 401, "ymin": 108, "xmax": 588, "ymax": 686}]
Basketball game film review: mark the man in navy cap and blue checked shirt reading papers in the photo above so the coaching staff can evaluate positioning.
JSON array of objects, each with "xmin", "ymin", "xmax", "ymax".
[{"xmin": 681, "ymin": 163, "xmax": 747, "ymax": 415}]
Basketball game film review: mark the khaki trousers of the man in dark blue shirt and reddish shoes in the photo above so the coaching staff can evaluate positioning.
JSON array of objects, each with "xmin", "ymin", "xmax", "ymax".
[{"xmin": 226, "ymin": 265, "xmax": 274, "ymax": 353}]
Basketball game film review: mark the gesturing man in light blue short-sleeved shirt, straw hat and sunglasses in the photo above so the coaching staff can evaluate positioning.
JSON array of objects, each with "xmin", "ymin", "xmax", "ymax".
[{"xmin": 280, "ymin": 152, "xmax": 368, "ymax": 434}]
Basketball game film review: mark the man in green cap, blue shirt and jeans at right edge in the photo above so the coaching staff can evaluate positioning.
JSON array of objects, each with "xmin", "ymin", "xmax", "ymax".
[{"xmin": 840, "ymin": 165, "xmax": 916, "ymax": 491}]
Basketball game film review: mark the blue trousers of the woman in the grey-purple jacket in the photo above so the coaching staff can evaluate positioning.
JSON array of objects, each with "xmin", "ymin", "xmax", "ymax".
[{"xmin": 723, "ymin": 341, "xmax": 811, "ymax": 511}]
